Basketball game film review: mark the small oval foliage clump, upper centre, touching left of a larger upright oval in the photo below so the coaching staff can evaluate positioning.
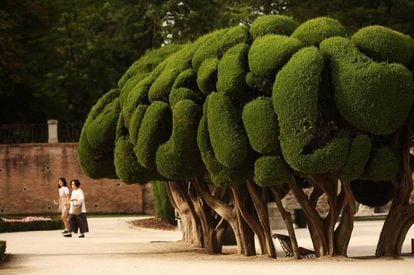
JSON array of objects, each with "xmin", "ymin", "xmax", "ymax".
[{"xmin": 197, "ymin": 57, "xmax": 218, "ymax": 95}]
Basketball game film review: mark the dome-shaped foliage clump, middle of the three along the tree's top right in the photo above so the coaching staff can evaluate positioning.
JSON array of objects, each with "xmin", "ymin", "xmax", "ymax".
[{"xmin": 292, "ymin": 17, "xmax": 346, "ymax": 46}]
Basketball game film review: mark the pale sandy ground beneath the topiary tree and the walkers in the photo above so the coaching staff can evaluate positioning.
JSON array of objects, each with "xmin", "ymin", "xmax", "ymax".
[{"xmin": 0, "ymin": 217, "xmax": 414, "ymax": 275}]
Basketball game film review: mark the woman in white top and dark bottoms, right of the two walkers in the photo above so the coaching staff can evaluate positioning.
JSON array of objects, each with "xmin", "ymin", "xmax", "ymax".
[{"xmin": 63, "ymin": 179, "xmax": 89, "ymax": 238}]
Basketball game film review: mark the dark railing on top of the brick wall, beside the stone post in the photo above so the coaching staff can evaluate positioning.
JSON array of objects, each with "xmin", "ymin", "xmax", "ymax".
[{"xmin": 0, "ymin": 122, "xmax": 82, "ymax": 144}]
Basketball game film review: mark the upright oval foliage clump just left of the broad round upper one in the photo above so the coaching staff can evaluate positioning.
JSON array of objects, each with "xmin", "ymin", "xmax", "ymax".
[{"xmin": 217, "ymin": 43, "xmax": 249, "ymax": 98}]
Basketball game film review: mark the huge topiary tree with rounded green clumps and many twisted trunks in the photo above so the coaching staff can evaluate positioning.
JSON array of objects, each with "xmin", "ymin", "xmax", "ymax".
[{"xmin": 79, "ymin": 15, "xmax": 414, "ymax": 258}]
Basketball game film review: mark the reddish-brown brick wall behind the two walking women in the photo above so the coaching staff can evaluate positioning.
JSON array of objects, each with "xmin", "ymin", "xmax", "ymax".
[{"xmin": 0, "ymin": 143, "xmax": 154, "ymax": 216}]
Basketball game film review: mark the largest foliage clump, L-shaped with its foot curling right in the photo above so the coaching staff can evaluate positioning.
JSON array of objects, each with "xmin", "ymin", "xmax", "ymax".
[{"xmin": 272, "ymin": 47, "xmax": 350, "ymax": 174}]
